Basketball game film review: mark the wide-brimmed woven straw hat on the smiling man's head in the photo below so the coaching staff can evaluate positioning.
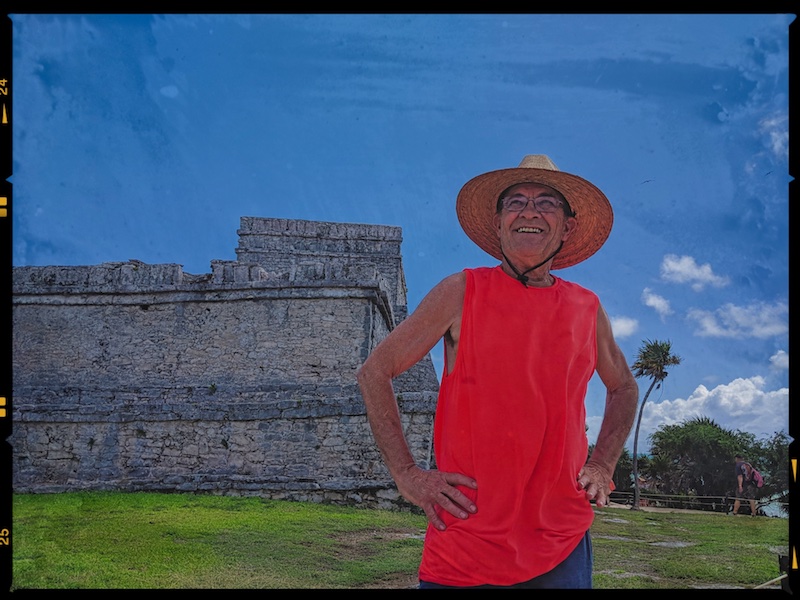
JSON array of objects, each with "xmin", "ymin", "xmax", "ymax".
[{"xmin": 456, "ymin": 154, "xmax": 614, "ymax": 269}]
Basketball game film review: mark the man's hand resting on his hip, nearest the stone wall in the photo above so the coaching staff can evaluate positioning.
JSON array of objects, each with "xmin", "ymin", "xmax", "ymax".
[{"xmin": 395, "ymin": 465, "xmax": 478, "ymax": 531}]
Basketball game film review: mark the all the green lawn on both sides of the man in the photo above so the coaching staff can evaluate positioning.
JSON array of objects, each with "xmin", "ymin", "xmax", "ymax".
[{"xmin": 7, "ymin": 492, "xmax": 789, "ymax": 590}]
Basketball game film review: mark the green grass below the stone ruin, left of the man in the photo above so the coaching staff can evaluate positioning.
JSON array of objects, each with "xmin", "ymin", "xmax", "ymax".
[{"xmin": 12, "ymin": 492, "xmax": 425, "ymax": 589}]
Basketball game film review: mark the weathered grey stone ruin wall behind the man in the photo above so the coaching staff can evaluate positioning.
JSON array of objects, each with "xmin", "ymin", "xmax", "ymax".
[{"xmin": 9, "ymin": 217, "xmax": 438, "ymax": 507}]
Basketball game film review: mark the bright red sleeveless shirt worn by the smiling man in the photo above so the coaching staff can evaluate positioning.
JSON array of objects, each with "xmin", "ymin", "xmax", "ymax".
[{"xmin": 419, "ymin": 266, "xmax": 599, "ymax": 586}]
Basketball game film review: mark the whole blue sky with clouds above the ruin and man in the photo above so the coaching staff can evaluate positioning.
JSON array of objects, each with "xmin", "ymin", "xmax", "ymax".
[{"xmin": 11, "ymin": 14, "xmax": 794, "ymax": 449}]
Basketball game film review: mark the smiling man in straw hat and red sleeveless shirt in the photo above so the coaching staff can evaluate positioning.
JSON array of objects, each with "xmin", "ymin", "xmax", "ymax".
[{"xmin": 358, "ymin": 155, "xmax": 638, "ymax": 589}]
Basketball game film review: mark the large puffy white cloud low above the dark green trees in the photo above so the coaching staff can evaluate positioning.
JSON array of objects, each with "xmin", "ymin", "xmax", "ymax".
[{"xmin": 630, "ymin": 376, "xmax": 789, "ymax": 451}]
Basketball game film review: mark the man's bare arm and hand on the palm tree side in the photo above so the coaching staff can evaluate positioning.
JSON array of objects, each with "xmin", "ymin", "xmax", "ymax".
[{"xmin": 578, "ymin": 306, "xmax": 639, "ymax": 506}]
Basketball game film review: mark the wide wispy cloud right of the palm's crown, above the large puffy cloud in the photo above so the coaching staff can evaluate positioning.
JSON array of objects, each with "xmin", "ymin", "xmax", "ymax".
[{"xmin": 687, "ymin": 302, "xmax": 789, "ymax": 338}]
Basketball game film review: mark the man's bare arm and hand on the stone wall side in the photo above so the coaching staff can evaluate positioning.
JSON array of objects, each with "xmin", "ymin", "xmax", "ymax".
[{"xmin": 357, "ymin": 273, "xmax": 477, "ymax": 529}]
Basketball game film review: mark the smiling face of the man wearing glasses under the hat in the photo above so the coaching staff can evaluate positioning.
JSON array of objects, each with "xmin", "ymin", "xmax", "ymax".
[{"xmin": 494, "ymin": 183, "xmax": 578, "ymax": 268}]
